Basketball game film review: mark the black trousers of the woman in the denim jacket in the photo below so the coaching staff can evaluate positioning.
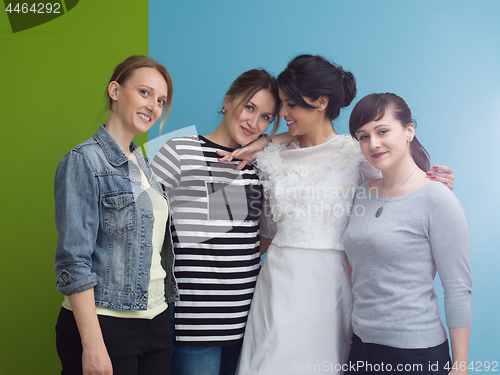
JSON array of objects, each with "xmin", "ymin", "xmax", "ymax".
[{"xmin": 56, "ymin": 307, "xmax": 172, "ymax": 375}]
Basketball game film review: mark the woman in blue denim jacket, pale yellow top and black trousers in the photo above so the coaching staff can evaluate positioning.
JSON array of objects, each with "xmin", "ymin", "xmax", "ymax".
[{"xmin": 54, "ymin": 56, "xmax": 178, "ymax": 375}]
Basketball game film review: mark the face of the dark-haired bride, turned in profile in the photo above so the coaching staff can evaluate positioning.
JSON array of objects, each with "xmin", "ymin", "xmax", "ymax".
[{"xmin": 280, "ymin": 89, "xmax": 328, "ymax": 136}]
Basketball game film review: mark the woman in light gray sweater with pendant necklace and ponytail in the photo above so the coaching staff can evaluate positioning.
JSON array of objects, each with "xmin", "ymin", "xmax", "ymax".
[{"xmin": 344, "ymin": 93, "xmax": 472, "ymax": 375}]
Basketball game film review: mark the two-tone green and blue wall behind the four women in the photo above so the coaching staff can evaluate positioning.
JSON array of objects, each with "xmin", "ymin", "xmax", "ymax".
[{"xmin": 0, "ymin": 0, "xmax": 500, "ymax": 375}]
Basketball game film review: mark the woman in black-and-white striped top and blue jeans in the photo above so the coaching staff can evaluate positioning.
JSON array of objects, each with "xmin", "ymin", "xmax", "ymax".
[{"xmin": 152, "ymin": 70, "xmax": 279, "ymax": 375}]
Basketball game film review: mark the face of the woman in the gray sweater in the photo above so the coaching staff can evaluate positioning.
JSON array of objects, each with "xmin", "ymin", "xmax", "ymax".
[{"xmin": 357, "ymin": 108, "xmax": 415, "ymax": 171}]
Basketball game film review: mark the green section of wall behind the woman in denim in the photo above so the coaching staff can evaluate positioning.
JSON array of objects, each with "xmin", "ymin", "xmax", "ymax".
[{"xmin": 0, "ymin": 0, "xmax": 148, "ymax": 375}]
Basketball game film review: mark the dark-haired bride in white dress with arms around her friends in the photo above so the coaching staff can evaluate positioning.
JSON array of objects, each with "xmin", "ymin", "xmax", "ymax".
[{"xmin": 221, "ymin": 55, "xmax": 453, "ymax": 375}]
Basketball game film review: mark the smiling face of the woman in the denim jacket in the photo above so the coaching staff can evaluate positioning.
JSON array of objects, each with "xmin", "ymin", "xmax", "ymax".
[{"xmin": 108, "ymin": 67, "xmax": 168, "ymax": 137}]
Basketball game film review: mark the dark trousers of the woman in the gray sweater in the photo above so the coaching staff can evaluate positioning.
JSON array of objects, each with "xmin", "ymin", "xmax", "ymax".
[{"xmin": 344, "ymin": 335, "xmax": 451, "ymax": 375}]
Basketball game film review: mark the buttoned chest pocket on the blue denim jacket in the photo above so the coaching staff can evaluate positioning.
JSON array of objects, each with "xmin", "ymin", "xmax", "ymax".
[{"xmin": 102, "ymin": 191, "xmax": 136, "ymax": 233}]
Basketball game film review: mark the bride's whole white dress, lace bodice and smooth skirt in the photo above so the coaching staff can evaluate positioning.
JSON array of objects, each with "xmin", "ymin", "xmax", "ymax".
[{"xmin": 237, "ymin": 135, "xmax": 379, "ymax": 375}]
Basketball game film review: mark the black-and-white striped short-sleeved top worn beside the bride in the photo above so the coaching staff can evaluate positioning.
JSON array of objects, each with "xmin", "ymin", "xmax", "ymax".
[{"xmin": 151, "ymin": 136, "xmax": 263, "ymax": 346}]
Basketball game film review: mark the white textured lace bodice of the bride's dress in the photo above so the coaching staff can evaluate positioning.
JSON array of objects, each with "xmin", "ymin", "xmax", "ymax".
[{"xmin": 256, "ymin": 135, "xmax": 379, "ymax": 250}]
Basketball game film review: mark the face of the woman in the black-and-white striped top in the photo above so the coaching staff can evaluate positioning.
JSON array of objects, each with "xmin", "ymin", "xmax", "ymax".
[{"xmin": 223, "ymin": 89, "xmax": 276, "ymax": 148}]
